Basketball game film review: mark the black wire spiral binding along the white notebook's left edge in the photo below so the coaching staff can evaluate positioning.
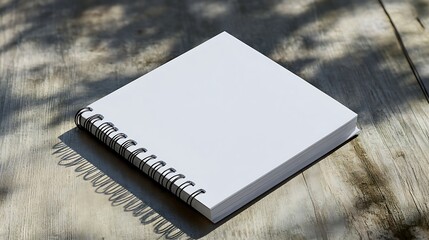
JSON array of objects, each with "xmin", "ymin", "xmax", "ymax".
[{"xmin": 74, "ymin": 107, "xmax": 206, "ymax": 206}]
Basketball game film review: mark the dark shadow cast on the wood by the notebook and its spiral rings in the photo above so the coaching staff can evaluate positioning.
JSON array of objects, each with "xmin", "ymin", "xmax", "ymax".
[{"xmin": 52, "ymin": 128, "xmax": 358, "ymax": 239}]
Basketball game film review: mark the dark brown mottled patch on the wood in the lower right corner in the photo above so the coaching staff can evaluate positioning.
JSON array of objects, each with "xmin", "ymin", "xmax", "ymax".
[{"xmin": 332, "ymin": 139, "xmax": 429, "ymax": 239}]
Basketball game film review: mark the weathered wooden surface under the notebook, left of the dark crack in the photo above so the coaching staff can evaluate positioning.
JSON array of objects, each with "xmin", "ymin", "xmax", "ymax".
[{"xmin": 0, "ymin": 0, "xmax": 429, "ymax": 239}]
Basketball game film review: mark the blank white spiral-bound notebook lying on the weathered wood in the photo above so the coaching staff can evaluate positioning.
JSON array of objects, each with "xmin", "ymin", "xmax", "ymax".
[{"xmin": 75, "ymin": 32, "xmax": 359, "ymax": 222}]
